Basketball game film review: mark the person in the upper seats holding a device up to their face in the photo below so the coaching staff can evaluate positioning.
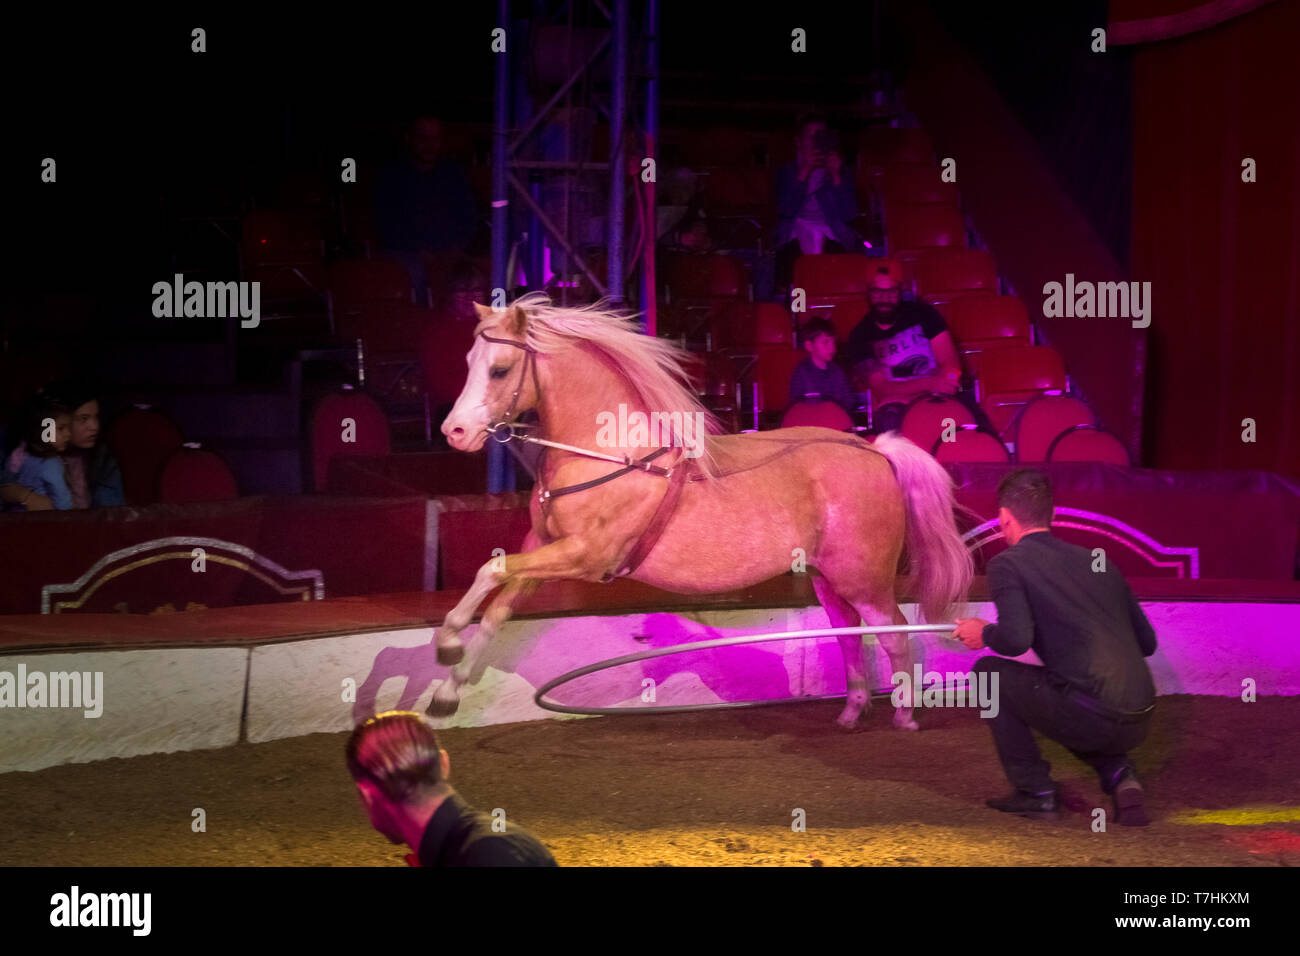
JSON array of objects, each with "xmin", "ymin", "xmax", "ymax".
[{"xmin": 775, "ymin": 114, "xmax": 862, "ymax": 289}]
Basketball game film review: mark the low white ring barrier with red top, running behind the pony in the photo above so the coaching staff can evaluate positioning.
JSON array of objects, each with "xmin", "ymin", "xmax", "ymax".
[{"xmin": 0, "ymin": 510, "xmax": 1300, "ymax": 771}]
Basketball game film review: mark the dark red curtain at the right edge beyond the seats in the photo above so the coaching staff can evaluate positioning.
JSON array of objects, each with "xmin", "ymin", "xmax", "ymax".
[{"xmin": 1128, "ymin": 3, "xmax": 1300, "ymax": 476}]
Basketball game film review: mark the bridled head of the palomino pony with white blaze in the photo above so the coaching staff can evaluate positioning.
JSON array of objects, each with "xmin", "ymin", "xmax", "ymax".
[{"xmin": 442, "ymin": 303, "xmax": 537, "ymax": 451}]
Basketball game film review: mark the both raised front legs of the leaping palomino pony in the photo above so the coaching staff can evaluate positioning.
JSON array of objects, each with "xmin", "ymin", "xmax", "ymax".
[{"xmin": 426, "ymin": 538, "xmax": 589, "ymax": 717}]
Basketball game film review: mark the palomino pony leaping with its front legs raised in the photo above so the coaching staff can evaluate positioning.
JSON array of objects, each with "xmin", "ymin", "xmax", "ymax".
[{"xmin": 429, "ymin": 293, "xmax": 972, "ymax": 730}]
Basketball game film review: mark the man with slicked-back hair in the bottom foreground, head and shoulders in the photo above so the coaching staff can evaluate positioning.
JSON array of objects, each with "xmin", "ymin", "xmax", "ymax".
[{"xmin": 346, "ymin": 710, "xmax": 555, "ymax": 866}]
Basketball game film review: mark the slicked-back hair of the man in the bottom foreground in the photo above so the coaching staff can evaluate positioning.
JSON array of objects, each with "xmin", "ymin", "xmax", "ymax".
[{"xmin": 345, "ymin": 710, "xmax": 442, "ymax": 804}]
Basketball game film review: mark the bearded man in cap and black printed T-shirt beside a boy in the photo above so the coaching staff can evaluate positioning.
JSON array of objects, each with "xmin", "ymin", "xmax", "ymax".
[{"xmin": 846, "ymin": 267, "xmax": 984, "ymax": 434}]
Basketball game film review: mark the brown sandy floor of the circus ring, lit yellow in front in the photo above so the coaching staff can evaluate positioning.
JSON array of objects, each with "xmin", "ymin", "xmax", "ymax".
[{"xmin": 0, "ymin": 696, "xmax": 1300, "ymax": 866}]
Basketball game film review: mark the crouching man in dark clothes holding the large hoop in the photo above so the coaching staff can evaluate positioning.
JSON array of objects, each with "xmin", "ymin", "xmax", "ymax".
[{"xmin": 953, "ymin": 468, "xmax": 1156, "ymax": 826}]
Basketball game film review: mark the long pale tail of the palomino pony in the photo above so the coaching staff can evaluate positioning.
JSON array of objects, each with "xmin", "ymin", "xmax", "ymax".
[{"xmin": 872, "ymin": 432, "xmax": 975, "ymax": 624}]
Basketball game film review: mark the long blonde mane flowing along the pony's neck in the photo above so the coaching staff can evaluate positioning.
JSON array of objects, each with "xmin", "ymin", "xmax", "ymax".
[{"xmin": 475, "ymin": 293, "xmax": 722, "ymax": 477}]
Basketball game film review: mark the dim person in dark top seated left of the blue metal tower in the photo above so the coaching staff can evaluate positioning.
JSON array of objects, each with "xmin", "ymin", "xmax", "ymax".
[{"xmin": 372, "ymin": 116, "xmax": 478, "ymax": 302}]
